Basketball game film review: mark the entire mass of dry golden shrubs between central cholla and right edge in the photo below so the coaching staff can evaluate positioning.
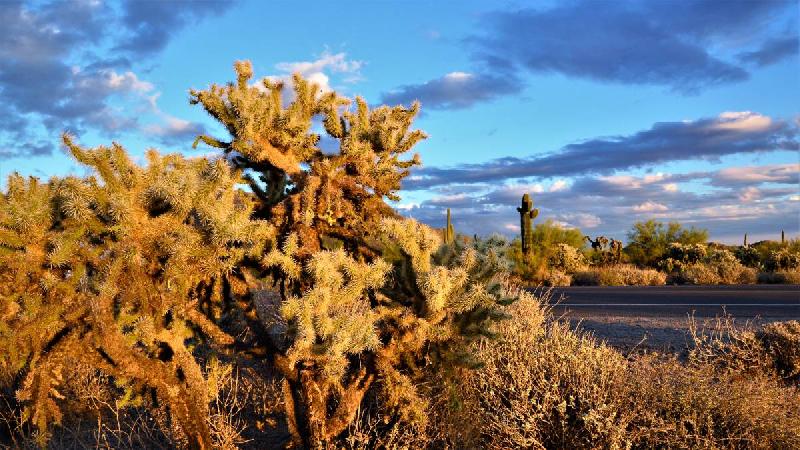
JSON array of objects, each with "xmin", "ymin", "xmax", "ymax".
[{"xmin": 446, "ymin": 299, "xmax": 800, "ymax": 449}]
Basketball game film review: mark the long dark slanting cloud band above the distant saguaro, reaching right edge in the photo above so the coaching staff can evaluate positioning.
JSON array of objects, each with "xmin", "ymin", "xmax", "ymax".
[{"xmin": 404, "ymin": 111, "xmax": 800, "ymax": 190}]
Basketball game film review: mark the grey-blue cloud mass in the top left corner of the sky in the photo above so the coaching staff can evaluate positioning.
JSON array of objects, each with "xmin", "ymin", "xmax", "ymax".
[{"xmin": 0, "ymin": 0, "xmax": 233, "ymax": 159}]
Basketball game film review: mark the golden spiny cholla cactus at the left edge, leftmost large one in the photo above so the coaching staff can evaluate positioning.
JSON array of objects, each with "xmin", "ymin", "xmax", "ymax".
[{"xmin": 0, "ymin": 136, "xmax": 272, "ymax": 448}]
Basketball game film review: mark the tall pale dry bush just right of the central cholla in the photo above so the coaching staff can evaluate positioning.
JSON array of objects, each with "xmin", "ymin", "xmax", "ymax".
[{"xmin": 452, "ymin": 298, "xmax": 629, "ymax": 449}]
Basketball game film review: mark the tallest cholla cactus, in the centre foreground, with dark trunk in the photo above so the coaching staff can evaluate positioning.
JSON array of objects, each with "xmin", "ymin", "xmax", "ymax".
[{"xmin": 191, "ymin": 62, "xmax": 505, "ymax": 447}]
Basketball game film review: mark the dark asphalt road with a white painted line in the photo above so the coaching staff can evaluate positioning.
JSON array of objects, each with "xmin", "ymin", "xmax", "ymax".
[{"xmin": 552, "ymin": 285, "xmax": 800, "ymax": 321}]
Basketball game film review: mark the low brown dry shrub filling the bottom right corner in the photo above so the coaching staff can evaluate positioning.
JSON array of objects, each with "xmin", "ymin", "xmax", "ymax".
[{"xmin": 624, "ymin": 356, "xmax": 800, "ymax": 449}]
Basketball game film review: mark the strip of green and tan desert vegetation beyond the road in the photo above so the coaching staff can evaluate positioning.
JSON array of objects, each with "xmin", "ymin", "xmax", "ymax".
[{"xmin": 490, "ymin": 213, "xmax": 800, "ymax": 286}]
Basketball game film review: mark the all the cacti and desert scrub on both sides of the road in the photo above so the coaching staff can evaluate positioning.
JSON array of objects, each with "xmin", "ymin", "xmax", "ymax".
[{"xmin": 0, "ymin": 62, "xmax": 800, "ymax": 448}]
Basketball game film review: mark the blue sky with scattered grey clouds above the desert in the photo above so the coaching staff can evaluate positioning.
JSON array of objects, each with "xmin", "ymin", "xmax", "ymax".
[{"xmin": 0, "ymin": 0, "xmax": 800, "ymax": 243}]
